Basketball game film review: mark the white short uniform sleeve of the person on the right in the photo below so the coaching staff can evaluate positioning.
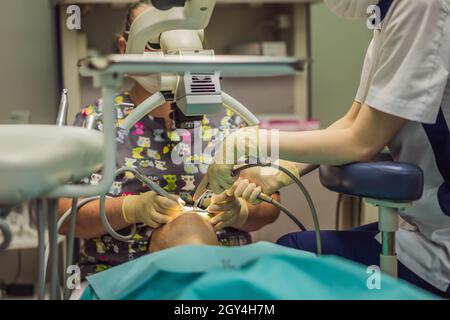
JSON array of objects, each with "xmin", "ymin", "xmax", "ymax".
[{"xmin": 357, "ymin": 0, "xmax": 450, "ymax": 123}]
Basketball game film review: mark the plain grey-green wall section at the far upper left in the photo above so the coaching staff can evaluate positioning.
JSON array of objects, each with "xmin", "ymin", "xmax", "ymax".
[{"xmin": 0, "ymin": 0, "xmax": 59, "ymax": 123}]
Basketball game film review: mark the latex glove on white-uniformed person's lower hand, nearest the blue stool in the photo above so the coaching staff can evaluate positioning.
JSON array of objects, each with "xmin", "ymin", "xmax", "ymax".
[{"xmin": 240, "ymin": 160, "xmax": 300, "ymax": 196}]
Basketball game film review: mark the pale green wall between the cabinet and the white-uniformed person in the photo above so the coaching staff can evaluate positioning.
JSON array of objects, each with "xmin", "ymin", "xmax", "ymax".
[{"xmin": 311, "ymin": 4, "xmax": 372, "ymax": 127}]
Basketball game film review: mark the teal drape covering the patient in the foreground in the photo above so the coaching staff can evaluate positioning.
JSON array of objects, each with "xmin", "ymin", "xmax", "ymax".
[{"xmin": 78, "ymin": 241, "xmax": 433, "ymax": 300}]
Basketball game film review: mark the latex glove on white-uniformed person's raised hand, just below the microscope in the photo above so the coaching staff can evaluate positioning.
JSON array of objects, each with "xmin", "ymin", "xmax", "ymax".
[{"xmin": 203, "ymin": 127, "xmax": 267, "ymax": 194}]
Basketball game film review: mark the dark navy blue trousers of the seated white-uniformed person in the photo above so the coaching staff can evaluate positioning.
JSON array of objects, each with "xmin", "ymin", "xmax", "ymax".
[{"xmin": 277, "ymin": 223, "xmax": 450, "ymax": 298}]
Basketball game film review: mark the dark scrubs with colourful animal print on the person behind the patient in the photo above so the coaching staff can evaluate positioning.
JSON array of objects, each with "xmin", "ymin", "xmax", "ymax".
[{"xmin": 75, "ymin": 92, "xmax": 251, "ymax": 278}]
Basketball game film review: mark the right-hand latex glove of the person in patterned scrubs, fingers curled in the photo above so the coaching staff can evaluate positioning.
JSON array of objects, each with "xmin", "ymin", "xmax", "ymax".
[{"xmin": 208, "ymin": 189, "xmax": 248, "ymax": 231}]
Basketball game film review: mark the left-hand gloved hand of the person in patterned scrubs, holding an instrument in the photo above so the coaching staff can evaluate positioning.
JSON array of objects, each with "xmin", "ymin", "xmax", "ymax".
[{"xmin": 122, "ymin": 191, "xmax": 183, "ymax": 228}]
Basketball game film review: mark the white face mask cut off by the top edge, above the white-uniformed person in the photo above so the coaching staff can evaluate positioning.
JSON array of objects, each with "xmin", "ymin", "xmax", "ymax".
[{"xmin": 325, "ymin": 0, "xmax": 380, "ymax": 20}]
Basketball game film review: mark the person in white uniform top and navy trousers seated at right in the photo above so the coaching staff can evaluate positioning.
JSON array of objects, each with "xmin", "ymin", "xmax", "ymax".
[{"xmin": 207, "ymin": 0, "xmax": 450, "ymax": 298}]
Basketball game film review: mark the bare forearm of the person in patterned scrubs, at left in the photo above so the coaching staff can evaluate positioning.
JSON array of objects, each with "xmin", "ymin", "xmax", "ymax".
[{"xmin": 59, "ymin": 197, "xmax": 129, "ymax": 239}]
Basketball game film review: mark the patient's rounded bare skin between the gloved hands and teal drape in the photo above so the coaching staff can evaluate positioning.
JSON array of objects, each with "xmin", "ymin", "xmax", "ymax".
[{"xmin": 149, "ymin": 213, "xmax": 219, "ymax": 252}]
